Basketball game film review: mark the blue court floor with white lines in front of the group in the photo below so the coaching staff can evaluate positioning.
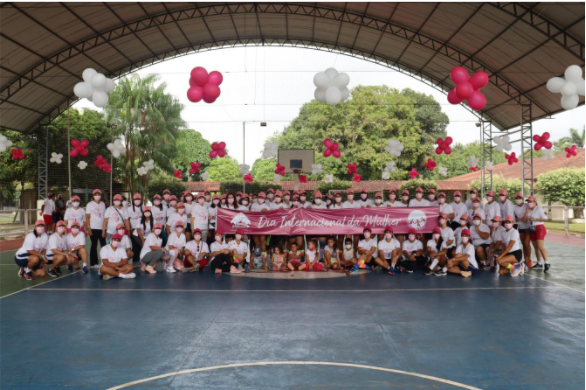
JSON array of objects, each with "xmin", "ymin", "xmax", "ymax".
[{"xmin": 0, "ymin": 244, "xmax": 585, "ymax": 390}]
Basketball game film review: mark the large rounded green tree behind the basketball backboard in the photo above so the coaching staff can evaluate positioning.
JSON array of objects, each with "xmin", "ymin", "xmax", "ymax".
[{"xmin": 273, "ymin": 86, "xmax": 449, "ymax": 180}]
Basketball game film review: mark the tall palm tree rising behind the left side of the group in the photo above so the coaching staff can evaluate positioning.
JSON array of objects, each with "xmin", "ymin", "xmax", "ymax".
[{"xmin": 106, "ymin": 74, "xmax": 185, "ymax": 192}]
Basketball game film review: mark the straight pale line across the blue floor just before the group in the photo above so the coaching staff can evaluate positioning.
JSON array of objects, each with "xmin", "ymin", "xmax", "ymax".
[{"xmin": 34, "ymin": 286, "xmax": 557, "ymax": 293}]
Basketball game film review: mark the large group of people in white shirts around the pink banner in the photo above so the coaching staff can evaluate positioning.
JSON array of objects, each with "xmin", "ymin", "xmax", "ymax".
[{"xmin": 15, "ymin": 188, "xmax": 550, "ymax": 280}]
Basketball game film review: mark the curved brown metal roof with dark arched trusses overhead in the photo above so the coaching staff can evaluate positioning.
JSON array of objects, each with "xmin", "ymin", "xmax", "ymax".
[{"xmin": 0, "ymin": 2, "xmax": 585, "ymax": 132}]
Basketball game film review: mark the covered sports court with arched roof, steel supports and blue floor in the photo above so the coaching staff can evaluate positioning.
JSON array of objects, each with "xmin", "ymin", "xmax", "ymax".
[{"xmin": 0, "ymin": 2, "xmax": 585, "ymax": 390}]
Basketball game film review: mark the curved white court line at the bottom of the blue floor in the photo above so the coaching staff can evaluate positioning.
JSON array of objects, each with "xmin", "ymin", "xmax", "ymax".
[{"xmin": 109, "ymin": 362, "xmax": 480, "ymax": 390}]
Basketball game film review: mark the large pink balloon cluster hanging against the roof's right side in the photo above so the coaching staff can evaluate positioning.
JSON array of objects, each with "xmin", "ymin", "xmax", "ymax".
[{"xmin": 448, "ymin": 66, "xmax": 488, "ymax": 111}]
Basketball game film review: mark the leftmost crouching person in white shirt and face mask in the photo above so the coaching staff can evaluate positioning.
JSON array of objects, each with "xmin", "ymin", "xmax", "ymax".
[{"xmin": 14, "ymin": 219, "xmax": 49, "ymax": 280}]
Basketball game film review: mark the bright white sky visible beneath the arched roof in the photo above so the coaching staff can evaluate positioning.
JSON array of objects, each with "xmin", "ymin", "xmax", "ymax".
[{"xmin": 74, "ymin": 47, "xmax": 585, "ymax": 166}]
